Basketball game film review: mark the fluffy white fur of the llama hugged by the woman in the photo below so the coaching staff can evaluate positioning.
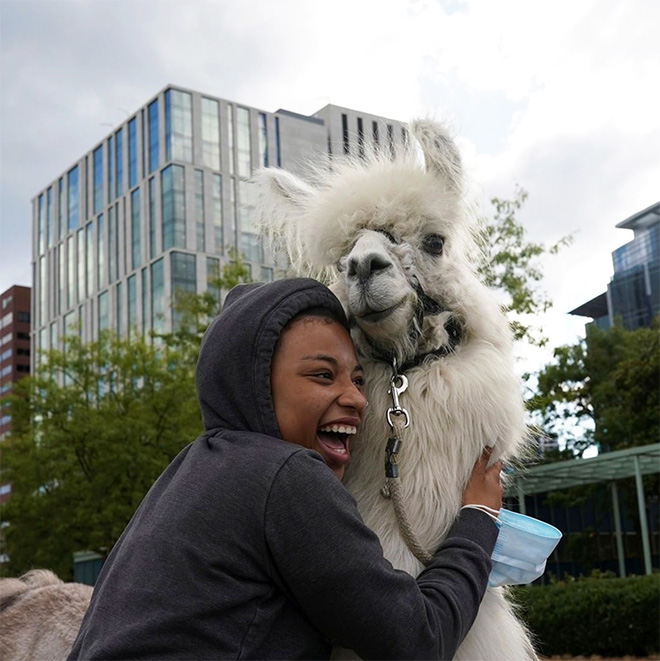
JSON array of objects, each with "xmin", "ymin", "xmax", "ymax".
[{"xmin": 257, "ymin": 121, "xmax": 536, "ymax": 661}]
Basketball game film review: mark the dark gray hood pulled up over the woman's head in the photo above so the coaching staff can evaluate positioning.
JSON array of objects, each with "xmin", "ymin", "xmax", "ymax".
[{"xmin": 196, "ymin": 278, "xmax": 348, "ymax": 438}]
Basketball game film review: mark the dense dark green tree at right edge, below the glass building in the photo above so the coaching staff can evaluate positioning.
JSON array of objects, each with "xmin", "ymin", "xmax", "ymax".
[{"xmin": 530, "ymin": 319, "xmax": 660, "ymax": 454}]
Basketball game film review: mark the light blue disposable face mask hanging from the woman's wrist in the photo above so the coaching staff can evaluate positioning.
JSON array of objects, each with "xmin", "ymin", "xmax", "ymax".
[{"xmin": 467, "ymin": 505, "xmax": 561, "ymax": 588}]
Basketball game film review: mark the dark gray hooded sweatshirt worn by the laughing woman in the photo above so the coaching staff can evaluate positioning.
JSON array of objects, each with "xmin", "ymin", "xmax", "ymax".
[{"xmin": 69, "ymin": 279, "xmax": 497, "ymax": 659}]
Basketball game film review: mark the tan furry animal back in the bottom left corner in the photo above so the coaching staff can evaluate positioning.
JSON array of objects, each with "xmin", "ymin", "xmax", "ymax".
[{"xmin": 0, "ymin": 569, "xmax": 92, "ymax": 661}]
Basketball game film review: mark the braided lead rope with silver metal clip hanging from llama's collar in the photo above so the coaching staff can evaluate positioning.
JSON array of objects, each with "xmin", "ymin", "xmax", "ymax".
[{"xmin": 381, "ymin": 358, "xmax": 433, "ymax": 565}]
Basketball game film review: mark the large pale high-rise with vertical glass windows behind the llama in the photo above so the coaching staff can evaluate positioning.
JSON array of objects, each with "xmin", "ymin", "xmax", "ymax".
[{"xmin": 32, "ymin": 86, "xmax": 406, "ymax": 360}]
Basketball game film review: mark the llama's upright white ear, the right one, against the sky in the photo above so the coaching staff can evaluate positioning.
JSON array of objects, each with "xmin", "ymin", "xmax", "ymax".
[{"xmin": 410, "ymin": 119, "xmax": 463, "ymax": 191}]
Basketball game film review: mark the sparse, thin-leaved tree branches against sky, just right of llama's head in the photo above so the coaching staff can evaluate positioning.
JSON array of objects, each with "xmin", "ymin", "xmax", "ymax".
[{"xmin": 479, "ymin": 188, "xmax": 572, "ymax": 346}]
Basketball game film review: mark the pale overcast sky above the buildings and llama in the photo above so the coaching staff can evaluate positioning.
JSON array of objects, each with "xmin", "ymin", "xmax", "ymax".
[{"xmin": 0, "ymin": 0, "xmax": 660, "ymax": 366}]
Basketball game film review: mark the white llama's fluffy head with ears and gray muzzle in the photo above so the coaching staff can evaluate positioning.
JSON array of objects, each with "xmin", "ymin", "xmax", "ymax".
[{"xmin": 257, "ymin": 121, "xmax": 502, "ymax": 365}]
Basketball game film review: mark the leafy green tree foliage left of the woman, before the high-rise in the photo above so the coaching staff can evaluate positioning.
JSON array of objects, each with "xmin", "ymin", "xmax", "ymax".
[{"xmin": 2, "ymin": 250, "xmax": 249, "ymax": 578}]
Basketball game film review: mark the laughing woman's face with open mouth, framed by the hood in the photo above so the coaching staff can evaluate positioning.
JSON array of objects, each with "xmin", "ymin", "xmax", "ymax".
[{"xmin": 270, "ymin": 316, "xmax": 366, "ymax": 479}]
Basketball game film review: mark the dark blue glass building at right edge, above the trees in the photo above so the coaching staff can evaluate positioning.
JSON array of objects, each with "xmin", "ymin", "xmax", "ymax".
[{"xmin": 570, "ymin": 202, "xmax": 660, "ymax": 330}]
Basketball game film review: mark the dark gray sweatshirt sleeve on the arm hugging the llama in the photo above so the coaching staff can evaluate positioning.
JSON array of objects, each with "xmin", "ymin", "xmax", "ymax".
[{"xmin": 265, "ymin": 451, "xmax": 497, "ymax": 659}]
